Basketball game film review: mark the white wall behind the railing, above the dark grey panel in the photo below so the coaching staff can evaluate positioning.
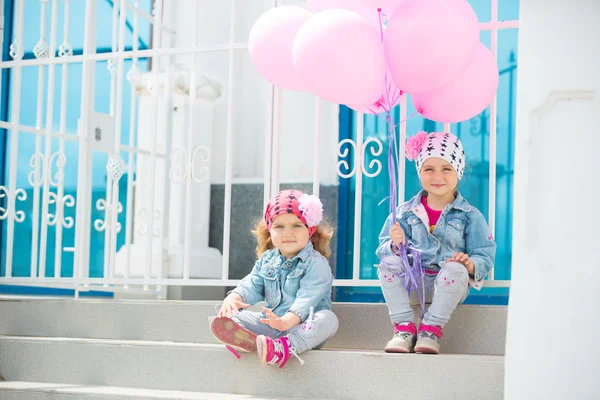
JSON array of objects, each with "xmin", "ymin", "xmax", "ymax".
[{"xmin": 165, "ymin": 0, "xmax": 338, "ymax": 188}]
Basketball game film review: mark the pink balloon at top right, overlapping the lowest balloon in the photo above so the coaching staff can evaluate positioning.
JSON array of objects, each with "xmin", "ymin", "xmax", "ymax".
[{"xmin": 385, "ymin": 0, "xmax": 479, "ymax": 93}]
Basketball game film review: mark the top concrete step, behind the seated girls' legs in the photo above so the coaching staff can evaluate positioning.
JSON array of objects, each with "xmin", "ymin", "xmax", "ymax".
[{"xmin": 0, "ymin": 298, "xmax": 506, "ymax": 355}]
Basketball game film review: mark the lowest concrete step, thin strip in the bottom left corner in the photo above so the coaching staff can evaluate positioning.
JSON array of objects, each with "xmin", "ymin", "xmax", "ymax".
[{"xmin": 0, "ymin": 382, "xmax": 326, "ymax": 400}]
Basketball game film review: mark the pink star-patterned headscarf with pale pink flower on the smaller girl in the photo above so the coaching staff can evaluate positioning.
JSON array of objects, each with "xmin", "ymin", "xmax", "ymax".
[{"xmin": 265, "ymin": 189, "xmax": 323, "ymax": 236}]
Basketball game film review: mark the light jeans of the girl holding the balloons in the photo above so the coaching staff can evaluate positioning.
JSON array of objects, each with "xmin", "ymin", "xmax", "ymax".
[{"xmin": 378, "ymin": 262, "xmax": 469, "ymax": 328}]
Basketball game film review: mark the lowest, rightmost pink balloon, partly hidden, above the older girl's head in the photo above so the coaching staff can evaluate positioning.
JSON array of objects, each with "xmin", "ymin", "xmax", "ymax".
[{"xmin": 412, "ymin": 43, "xmax": 500, "ymax": 123}]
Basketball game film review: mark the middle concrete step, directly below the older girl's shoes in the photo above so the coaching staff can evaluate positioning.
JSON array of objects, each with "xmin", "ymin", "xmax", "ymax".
[{"xmin": 0, "ymin": 336, "xmax": 504, "ymax": 400}]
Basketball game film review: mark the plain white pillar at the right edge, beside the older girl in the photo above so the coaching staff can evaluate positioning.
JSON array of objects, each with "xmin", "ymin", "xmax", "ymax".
[{"xmin": 505, "ymin": 0, "xmax": 600, "ymax": 400}]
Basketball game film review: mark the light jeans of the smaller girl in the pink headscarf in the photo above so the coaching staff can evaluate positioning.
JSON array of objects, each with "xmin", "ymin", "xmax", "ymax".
[{"xmin": 232, "ymin": 310, "xmax": 339, "ymax": 354}]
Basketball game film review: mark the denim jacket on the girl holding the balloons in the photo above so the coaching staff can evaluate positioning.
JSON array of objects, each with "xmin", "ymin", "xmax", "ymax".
[{"xmin": 377, "ymin": 190, "xmax": 496, "ymax": 289}]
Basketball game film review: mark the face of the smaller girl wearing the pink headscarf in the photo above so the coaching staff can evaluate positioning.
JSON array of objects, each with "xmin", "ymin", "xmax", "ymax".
[{"xmin": 269, "ymin": 214, "xmax": 310, "ymax": 260}]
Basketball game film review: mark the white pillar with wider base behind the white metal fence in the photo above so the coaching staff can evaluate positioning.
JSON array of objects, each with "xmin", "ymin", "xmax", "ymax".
[{"xmin": 115, "ymin": 66, "xmax": 222, "ymax": 279}]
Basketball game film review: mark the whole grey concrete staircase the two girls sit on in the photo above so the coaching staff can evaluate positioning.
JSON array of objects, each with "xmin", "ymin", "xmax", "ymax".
[{"xmin": 0, "ymin": 298, "xmax": 506, "ymax": 400}]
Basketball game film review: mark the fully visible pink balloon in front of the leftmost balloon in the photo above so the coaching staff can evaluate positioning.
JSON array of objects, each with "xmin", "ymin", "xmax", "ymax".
[{"xmin": 294, "ymin": 9, "xmax": 385, "ymax": 104}]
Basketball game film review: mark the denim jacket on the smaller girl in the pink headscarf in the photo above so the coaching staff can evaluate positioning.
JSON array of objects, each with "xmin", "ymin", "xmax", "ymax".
[{"xmin": 231, "ymin": 241, "xmax": 333, "ymax": 322}]
